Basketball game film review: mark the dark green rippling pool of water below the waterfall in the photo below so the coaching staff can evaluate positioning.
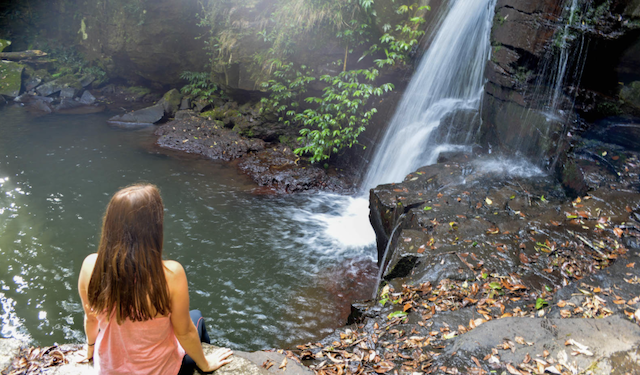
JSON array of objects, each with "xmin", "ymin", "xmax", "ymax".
[{"xmin": 0, "ymin": 108, "xmax": 375, "ymax": 350}]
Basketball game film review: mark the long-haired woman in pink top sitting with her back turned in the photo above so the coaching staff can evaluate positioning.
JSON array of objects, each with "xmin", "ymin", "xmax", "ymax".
[{"xmin": 78, "ymin": 184, "xmax": 232, "ymax": 375}]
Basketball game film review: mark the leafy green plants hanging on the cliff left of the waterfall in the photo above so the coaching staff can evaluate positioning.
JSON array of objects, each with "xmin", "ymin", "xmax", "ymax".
[{"xmin": 194, "ymin": 0, "xmax": 430, "ymax": 162}]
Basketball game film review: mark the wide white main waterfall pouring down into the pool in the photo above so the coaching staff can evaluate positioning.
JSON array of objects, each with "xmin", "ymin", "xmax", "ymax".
[{"xmin": 362, "ymin": 0, "xmax": 496, "ymax": 191}]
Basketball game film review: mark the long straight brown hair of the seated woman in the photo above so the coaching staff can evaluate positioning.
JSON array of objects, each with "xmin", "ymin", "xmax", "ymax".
[{"xmin": 88, "ymin": 184, "xmax": 171, "ymax": 324}]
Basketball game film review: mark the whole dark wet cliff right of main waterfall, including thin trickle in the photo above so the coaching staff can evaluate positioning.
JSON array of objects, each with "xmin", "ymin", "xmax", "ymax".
[{"xmin": 481, "ymin": 0, "xmax": 640, "ymax": 168}]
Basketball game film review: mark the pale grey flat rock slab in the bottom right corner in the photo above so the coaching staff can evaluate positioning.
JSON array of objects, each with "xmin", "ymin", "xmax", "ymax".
[{"xmin": 442, "ymin": 315, "xmax": 640, "ymax": 374}]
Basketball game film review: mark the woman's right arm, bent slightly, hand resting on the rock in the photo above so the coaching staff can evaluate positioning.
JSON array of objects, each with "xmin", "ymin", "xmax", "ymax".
[{"xmin": 165, "ymin": 261, "xmax": 233, "ymax": 372}]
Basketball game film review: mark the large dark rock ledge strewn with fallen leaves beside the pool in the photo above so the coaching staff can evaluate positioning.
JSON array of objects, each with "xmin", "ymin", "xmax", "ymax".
[{"xmin": 312, "ymin": 143, "xmax": 640, "ymax": 374}]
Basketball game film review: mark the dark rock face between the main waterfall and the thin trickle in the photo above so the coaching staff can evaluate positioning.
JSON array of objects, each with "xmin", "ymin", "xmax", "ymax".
[{"xmin": 482, "ymin": 0, "xmax": 562, "ymax": 164}]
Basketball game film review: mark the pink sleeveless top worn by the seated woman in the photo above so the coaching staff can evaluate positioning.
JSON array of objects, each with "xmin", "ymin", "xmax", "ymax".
[{"xmin": 94, "ymin": 314, "xmax": 185, "ymax": 375}]
